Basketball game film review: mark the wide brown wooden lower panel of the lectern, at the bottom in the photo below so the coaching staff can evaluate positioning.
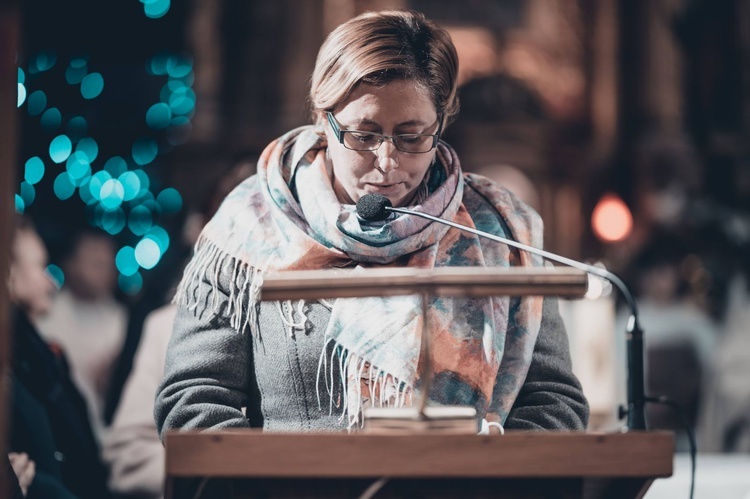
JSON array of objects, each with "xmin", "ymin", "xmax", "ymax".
[{"xmin": 165, "ymin": 430, "xmax": 674, "ymax": 498}]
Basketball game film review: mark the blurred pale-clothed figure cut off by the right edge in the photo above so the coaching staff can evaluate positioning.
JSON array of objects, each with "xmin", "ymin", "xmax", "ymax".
[{"xmin": 698, "ymin": 275, "xmax": 750, "ymax": 452}]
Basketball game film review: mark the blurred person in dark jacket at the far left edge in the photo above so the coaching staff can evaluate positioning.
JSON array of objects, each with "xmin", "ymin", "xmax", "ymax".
[{"xmin": 8, "ymin": 217, "xmax": 109, "ymax": 499}]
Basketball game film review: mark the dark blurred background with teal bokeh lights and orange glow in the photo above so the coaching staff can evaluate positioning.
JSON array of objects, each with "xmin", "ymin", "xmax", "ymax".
[{"xmin": 5, "ymin": 0, "xmax": 750, "ymax": 458}]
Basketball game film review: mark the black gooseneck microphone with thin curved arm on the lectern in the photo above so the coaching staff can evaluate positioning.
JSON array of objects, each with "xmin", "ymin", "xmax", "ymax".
[{"xmin": 357, "ymin": 194, "xmax": 646, "ymax": 430}]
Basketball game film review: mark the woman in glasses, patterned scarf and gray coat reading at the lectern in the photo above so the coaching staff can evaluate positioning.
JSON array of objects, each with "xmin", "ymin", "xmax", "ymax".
[{"xmin": 155, "ymin": 12, "xmax": 588, "ymax": 435}]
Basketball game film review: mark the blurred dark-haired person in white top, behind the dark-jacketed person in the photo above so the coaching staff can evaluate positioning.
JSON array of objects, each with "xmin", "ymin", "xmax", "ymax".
[{"xmin": 37, "ymin": 232, "xmax": 127, "ymax": 439}]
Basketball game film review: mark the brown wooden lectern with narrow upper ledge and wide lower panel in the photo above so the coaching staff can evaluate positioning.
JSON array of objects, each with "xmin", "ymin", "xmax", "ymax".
[{"xmin": 165, "ymin": 268, "xmax": 674, "ymax": 499}]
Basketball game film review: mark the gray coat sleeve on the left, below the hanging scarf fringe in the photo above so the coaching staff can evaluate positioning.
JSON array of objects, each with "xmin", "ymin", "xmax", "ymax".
[{"xmin": 154, "ymin": 266, "xmax": 252, "ymax": 440}]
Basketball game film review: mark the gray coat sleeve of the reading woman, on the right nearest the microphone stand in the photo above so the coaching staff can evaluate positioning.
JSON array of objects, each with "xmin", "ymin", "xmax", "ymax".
[{"xmin": 505, "ymin": 297, "xmax": 589, "ymax": 430}]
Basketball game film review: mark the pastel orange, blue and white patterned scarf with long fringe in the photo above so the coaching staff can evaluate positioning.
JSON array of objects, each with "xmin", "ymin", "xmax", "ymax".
[{"xmin": 175, "ymin": 127, "xmax": 542, "ymax": 426}]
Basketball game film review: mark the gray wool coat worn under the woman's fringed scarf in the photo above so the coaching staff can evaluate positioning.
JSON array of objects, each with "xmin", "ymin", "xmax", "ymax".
[{"xmin": 154, "ymin": 266, "xmax": 588, "ymax": 438}]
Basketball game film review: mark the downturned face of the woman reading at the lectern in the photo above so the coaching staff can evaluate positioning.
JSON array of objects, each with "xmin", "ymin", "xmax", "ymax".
[{"xmin": 323, "ymin": 80, "xmax": 439, "ymax": 206}]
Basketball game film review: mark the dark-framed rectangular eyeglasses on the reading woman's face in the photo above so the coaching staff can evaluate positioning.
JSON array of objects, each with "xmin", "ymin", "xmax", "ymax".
[{"xmin": 326, "ymin": 112, "xmax": 443, "ymax": 154}]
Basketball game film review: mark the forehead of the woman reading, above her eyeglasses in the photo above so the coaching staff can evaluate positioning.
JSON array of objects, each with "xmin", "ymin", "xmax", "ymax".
[{"xmin": 336, "ymin": 80, "xmax": 437, "ymax": 124}]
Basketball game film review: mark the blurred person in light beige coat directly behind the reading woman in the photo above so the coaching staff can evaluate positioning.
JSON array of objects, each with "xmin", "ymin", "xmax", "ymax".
[{"xmin": 103, "ymin": 161, "xmax": 255, "ymax": 499}]
